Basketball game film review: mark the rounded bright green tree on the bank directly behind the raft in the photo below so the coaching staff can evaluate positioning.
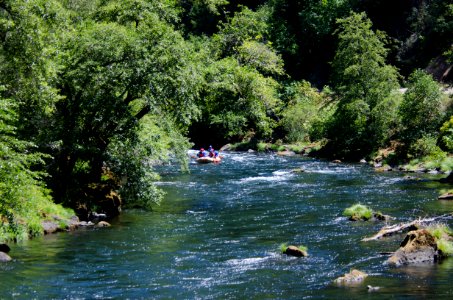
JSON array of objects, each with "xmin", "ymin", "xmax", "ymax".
[{"xmin": 205, "ymin": 58, "xmax": 279, "ymax": 140}]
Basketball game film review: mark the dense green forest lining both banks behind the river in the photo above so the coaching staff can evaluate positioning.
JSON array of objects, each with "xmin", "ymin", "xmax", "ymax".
[{"xmin": 0, "ymin": 0, "xmax": 453, "ymax": 239}]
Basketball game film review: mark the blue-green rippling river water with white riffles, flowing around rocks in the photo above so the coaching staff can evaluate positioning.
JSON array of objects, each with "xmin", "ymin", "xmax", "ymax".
[{"xmin": 0, "ymin": 153, "xmax": 453, "ymax": 299}]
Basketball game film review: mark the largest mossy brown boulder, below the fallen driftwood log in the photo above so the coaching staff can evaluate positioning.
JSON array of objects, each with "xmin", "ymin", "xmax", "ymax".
[{"xmin": 387, "ymin": 229, "xmax": 439, "ymax": 266}]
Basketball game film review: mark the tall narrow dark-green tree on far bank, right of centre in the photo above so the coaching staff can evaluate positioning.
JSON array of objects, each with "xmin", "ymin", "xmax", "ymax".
[{"xmin": 328, "ymin": 13, "xmax": 399, "ymax": 156}]
